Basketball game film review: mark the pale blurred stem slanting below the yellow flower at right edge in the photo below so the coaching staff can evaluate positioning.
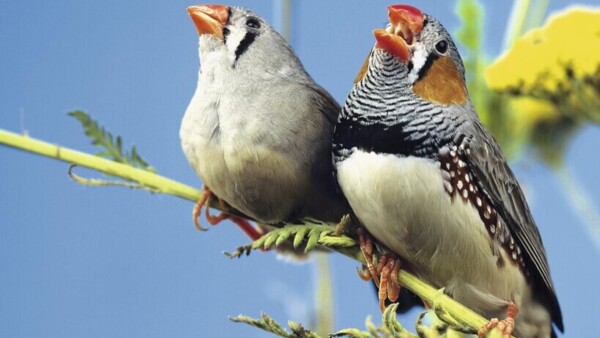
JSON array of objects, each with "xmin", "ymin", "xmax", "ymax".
[{"xmin": 552, "ymin": 164, "xmax": 600, "ymax": 249}]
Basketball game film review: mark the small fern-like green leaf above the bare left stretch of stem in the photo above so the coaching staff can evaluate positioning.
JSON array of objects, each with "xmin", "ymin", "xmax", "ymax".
[{"xmin": 68, "ymin": 110, "xmax": 156, "ymax": 173}]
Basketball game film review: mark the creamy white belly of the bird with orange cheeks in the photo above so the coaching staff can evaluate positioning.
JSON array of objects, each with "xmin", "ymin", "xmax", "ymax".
[{"xmin": 336, "ymin": 151, "xmax": 526, "ymax": 315}]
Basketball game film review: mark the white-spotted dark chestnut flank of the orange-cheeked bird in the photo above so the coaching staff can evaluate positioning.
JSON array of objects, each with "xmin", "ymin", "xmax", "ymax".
[{"xmin": 439, "ymin": 144, "xmax": 528, "ymax": 275}]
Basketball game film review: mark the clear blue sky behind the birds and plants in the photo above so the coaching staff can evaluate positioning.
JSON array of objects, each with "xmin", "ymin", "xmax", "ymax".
[{"xmin": 0, "ymin": 0, "xmax": 600, "ymax": 337}]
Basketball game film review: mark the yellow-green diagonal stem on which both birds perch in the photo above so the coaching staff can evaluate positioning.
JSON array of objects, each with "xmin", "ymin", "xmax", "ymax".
[{"xmin": 0, "ymin": 129, "xmax": 506, "ymax": 331}]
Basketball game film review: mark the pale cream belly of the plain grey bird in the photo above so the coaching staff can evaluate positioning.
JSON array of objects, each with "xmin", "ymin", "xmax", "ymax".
[{"xmin": 180, "ymin": 107, "xmax": 308, "ymax": 223}]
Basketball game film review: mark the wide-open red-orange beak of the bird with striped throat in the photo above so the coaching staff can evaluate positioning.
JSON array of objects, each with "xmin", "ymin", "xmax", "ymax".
[{"xmin": 373, "ymin": 5, "xmax": 424, "ymax": 61}]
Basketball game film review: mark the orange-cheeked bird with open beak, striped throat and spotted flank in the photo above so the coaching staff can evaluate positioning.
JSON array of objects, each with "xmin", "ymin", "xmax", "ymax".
[{"xmin": 333, "ymin": 5, "xmax": 564, "ymax": 337}]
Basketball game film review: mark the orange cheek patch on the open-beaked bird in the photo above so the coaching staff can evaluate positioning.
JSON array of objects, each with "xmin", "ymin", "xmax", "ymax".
[{"xmin": 413, "ymin": 56, "xmax": 469, "ymax": 105}]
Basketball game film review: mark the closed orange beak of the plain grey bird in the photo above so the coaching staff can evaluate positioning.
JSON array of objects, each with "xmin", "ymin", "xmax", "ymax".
[{"xmin": 188, "ymin": 5, "xmax": 229, "ymax": 40}]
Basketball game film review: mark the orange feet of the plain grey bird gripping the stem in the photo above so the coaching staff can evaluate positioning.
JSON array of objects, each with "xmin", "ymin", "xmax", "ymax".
[{"xmin": 192, "ymin": 186, "xmax": 263, "ymax": 241}]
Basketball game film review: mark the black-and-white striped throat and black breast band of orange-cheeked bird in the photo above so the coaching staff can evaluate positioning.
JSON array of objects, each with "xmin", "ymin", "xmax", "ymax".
[{"xmin": 335, "ymin": 56, "xmax": 470, "ymax": 157}]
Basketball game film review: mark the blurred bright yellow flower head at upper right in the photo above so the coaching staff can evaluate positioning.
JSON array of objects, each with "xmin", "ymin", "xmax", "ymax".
[{"xmin": 485, "ymin": 7, "xmax": 600, "ymax": 92}]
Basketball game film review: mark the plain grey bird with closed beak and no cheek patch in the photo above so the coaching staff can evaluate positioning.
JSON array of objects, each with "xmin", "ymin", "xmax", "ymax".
[{"xmin": 180, "ymin": 5, "xmax": 347, "ymax": 239}]
